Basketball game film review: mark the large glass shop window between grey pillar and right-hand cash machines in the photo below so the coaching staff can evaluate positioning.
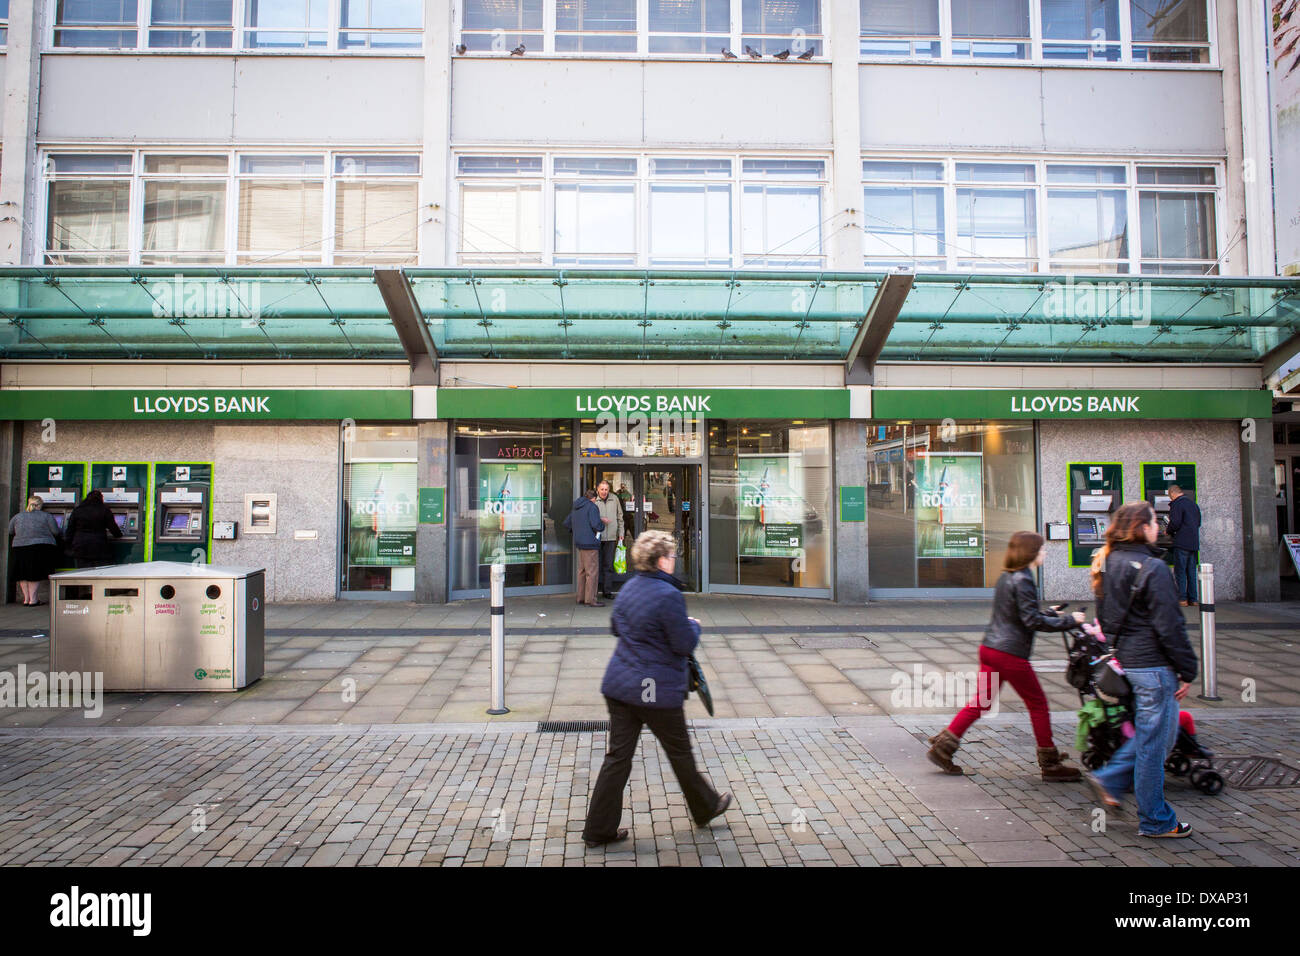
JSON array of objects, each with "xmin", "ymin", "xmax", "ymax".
[{"xmin": 867, "ymin": 423, "xmax": 1037, "ymax": 591}]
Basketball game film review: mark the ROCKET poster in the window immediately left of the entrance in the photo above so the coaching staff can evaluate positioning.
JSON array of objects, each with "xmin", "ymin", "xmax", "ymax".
[{"xmin": 478, "ymin": 458, "xmax": 542, "ymax": 564}]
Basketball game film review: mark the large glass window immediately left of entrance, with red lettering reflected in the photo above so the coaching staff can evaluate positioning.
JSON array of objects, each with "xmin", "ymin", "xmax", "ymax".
[{"xmin": 449, "ymin": 420, "xmax": 577, "ymax": 596}]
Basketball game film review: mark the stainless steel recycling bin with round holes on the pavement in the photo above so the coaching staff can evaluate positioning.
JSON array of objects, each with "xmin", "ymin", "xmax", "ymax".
[{"xmin": 49, "ymin": 561, "xmax": 267, "ymax": 691}]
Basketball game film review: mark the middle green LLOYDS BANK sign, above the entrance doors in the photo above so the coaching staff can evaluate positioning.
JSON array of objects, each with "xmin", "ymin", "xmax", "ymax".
[{"xmin": 438, "ymin": 388, "xmax": 849, "ymax": 419}]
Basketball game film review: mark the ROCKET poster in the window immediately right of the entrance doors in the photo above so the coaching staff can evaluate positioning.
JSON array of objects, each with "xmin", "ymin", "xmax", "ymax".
[{"xmin": 737, "ymin": 453, "xmax": 807, "ymax": 558}]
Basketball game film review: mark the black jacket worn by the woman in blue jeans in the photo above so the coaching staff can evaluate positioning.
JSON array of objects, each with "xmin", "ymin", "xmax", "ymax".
[{"xmin": 1097, "ymin": 544, "xmax": 1197, "ymax": 683}]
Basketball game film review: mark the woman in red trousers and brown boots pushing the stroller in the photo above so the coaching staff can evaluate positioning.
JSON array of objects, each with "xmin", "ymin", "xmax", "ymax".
[{"xmin": 928, "ymin": 531, "xmax": 1084, "ymax": 782}]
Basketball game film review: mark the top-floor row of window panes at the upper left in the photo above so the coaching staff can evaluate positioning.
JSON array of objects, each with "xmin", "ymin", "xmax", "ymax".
[{"xmin": 53, "ymin": 0, "xmax": 423, "ymax": 52}]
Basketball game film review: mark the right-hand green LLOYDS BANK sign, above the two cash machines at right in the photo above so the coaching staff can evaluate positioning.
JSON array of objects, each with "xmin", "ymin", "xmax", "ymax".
[{"xmin": 871, "ymin": 389, "xmax": 1273, "ymax": 420}]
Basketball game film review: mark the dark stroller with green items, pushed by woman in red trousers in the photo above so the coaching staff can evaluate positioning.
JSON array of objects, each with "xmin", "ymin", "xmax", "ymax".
[{"xmin": 1054, "ymin": 605, "xmax": 1223, "ymax": 795}]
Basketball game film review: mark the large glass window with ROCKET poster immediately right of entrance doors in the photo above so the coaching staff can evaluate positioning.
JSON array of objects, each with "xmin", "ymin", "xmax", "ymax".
[{"xmin": 709, "ymin": 420, "xmax": 832, "ymax": 592}]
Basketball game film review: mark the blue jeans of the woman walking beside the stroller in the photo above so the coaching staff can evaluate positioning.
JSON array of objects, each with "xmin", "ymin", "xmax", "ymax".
[{"xmin": 1093, "ymin": 667, "xmax": 1178, "ymax": 834}]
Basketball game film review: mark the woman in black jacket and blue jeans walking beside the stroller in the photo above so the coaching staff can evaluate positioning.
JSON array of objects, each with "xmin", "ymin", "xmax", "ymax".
[{"xmin": 1088, "ymin": 501, "xmax": 1197, "ymax": 838}]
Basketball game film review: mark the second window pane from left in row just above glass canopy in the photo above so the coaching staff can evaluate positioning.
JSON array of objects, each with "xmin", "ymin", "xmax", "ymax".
[{"xmin": 140, "ymin": 156, "xmax": 230, "ymax": 265}]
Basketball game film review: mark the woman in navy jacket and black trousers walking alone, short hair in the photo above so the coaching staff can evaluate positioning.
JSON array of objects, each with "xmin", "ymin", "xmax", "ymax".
[{"xmin": 582, "ymin": 531, "xmax": 731, "ymax": 847}]
